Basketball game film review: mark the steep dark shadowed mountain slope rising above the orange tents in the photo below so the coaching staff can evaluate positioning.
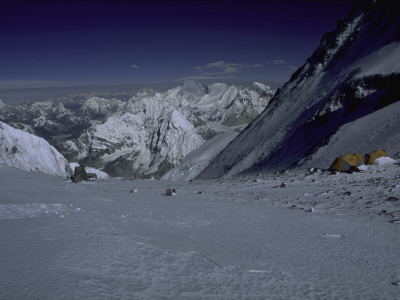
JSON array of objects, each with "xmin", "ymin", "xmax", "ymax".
[{"xmin": 200, "ymin": 1, "xmax": 400, "ymax": 178}]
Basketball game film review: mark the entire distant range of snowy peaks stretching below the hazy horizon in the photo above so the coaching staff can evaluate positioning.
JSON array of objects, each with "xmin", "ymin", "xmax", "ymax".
[{"xmin": 0, "ymin": 81, "xmax": 275, "ymax": 178}]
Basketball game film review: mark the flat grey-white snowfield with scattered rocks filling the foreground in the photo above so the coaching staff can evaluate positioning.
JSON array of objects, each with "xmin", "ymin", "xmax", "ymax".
[{"xmin": 0, "ymin": 163, "xmax": 400, "ymax": 299}]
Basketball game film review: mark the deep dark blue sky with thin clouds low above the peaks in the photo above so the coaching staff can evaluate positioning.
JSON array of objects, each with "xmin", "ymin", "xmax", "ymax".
[{"xmin": 0, "ymin": 0, "xmax": 352, "ymax": 89}]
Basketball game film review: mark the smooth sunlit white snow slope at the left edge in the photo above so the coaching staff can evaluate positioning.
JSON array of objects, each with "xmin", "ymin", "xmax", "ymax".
[{"xmin": 0, "ymin": 122, "xmax": 72, "ymax": 177}]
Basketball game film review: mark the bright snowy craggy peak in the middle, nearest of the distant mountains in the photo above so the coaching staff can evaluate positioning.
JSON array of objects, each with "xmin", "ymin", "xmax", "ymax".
[{"xmin": 63, "ymin": 102, "xmax": 204, "ymax": 178}]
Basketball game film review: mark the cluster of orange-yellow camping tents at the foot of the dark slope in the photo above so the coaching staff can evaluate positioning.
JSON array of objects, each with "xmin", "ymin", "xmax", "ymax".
[{"xmin": 329, "ymin": 150, "xmax": 387, "ymax": 172}]
